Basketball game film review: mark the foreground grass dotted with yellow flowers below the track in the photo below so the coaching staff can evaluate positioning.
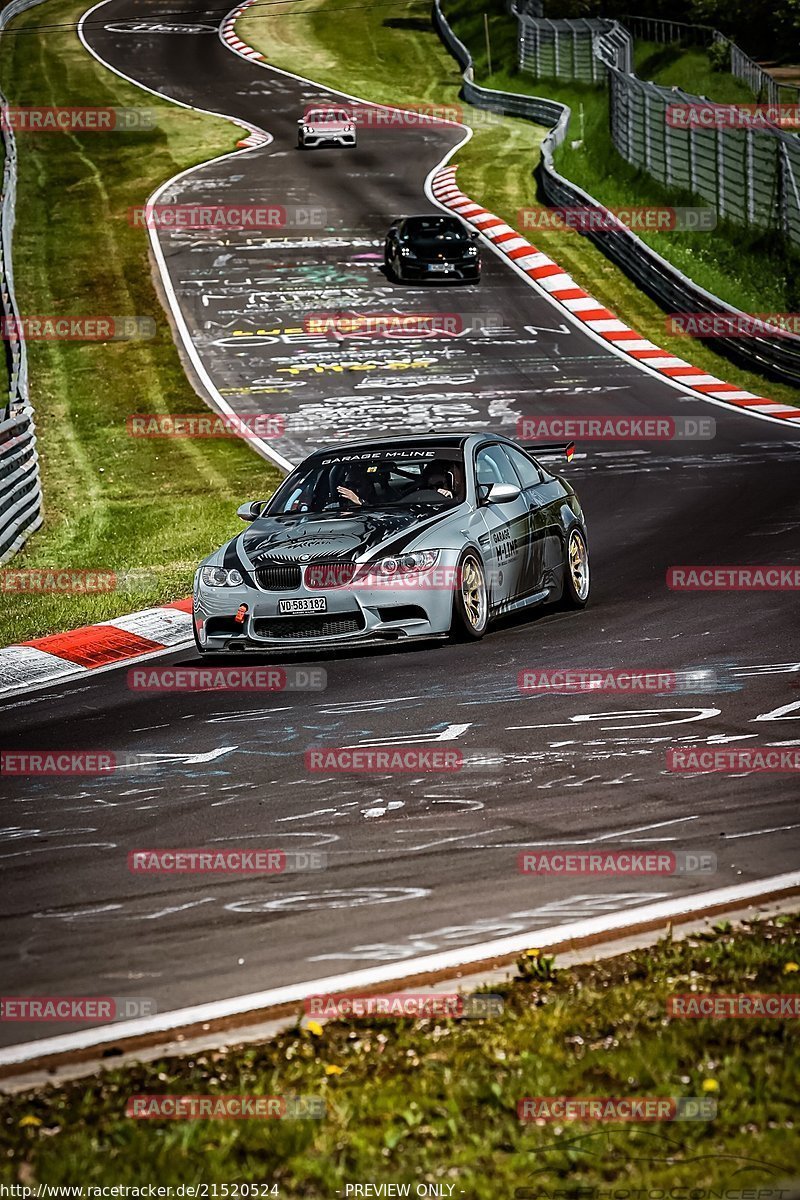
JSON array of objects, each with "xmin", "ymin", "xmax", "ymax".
[{"xmin": 0, "ymin": 916, "xmax": 800, "ymax": 1185}]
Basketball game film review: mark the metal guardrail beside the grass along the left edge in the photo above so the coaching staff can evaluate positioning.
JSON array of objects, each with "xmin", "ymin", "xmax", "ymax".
[{"xmin": 0, "ymin": 0, "xmax": 44, "ymax": 563}]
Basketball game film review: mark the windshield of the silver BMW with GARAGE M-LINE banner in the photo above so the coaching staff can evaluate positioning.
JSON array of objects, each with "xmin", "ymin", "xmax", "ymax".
[{"xmin": 265, "ymin": 445, "xmax": 464, "ymax": 516}]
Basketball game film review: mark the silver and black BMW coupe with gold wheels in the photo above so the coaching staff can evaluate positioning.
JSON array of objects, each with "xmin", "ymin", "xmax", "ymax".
[{"xmin": 193, "ymin": 433, "xmax": 589, "ymax": 654}]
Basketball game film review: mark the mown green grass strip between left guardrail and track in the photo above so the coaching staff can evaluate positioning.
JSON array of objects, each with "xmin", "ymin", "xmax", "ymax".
[{"xmin": 0, "ymin": 0, "xmax": 278, "ymax": 646}]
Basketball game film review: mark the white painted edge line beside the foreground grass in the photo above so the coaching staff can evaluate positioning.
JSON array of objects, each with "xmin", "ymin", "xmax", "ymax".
[{"xmin": 0, "ymin": 871, "xmax": 800, "ymax": 1067}]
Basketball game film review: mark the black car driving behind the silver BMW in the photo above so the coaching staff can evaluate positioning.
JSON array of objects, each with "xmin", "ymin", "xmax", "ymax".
[{"xmin": 384, "ymin": 214, "xmax": 481, "ymax": 283}]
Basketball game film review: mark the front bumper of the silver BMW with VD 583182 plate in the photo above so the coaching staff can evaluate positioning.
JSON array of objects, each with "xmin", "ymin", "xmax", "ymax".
[{"xmin": 193, "ymin": 572, "xmax": 453, "ymax": 653}]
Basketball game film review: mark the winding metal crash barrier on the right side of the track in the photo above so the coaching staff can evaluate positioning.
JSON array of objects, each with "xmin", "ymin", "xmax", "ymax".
[{"xmin": 433, "ymin": 0, "xmax": 800, "ymax": 385}]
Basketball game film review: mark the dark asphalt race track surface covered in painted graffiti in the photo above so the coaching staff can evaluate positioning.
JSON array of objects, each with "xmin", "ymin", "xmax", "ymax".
[{"xmin": 0, "ymin": 0, "xmax": 800, "ymax": 1044}]
